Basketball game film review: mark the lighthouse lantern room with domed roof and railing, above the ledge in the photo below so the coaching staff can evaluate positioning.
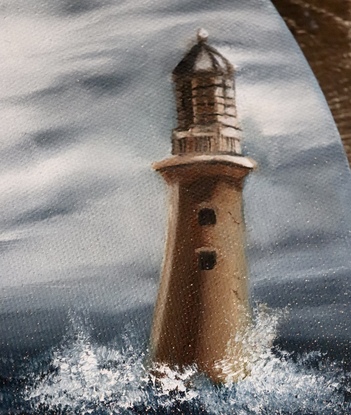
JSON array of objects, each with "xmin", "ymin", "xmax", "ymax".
[{"xmin": 172, "ymin": 29, "xmax": 241, "ymax": 155}]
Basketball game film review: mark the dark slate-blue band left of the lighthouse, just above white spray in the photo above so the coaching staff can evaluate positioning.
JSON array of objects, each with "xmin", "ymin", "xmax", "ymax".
[{"xmin": 0, "ymin": 304, "xmax": 153, "ymax": 380}]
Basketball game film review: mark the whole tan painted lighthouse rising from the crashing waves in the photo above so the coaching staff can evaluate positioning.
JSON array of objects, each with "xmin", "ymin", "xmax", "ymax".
[{"xmin": 151, "ymin": 29, "xmax": 255, "ymax": 382}]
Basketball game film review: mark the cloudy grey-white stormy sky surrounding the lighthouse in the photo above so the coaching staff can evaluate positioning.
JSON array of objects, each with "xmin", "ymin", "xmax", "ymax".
[{"xmin": 0, "ymin": 0, "xmax": 351, "ymax": 358}]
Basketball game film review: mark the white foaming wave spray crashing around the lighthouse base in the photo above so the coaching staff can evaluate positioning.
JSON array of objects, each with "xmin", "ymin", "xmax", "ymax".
[{"xmin": 24, "ymin": 307, "xmax": 351, "ymax": 415}]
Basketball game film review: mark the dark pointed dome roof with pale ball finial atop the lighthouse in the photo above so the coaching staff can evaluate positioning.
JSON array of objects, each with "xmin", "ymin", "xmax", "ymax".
[{"xmin": 173, "ymin": 29, "xmax": 234, "ymax": 76}]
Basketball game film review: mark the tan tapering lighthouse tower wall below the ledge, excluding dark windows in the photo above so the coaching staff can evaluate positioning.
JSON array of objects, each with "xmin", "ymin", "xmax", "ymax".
[{"xmin": 151, "ymin": 158, "xmax": 253, "ymax": 381}]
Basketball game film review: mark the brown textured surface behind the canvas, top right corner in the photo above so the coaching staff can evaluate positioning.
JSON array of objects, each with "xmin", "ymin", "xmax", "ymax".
[{"xmin": 272, "ymin": 0, "xmax": 351, "ymax": 164}]
